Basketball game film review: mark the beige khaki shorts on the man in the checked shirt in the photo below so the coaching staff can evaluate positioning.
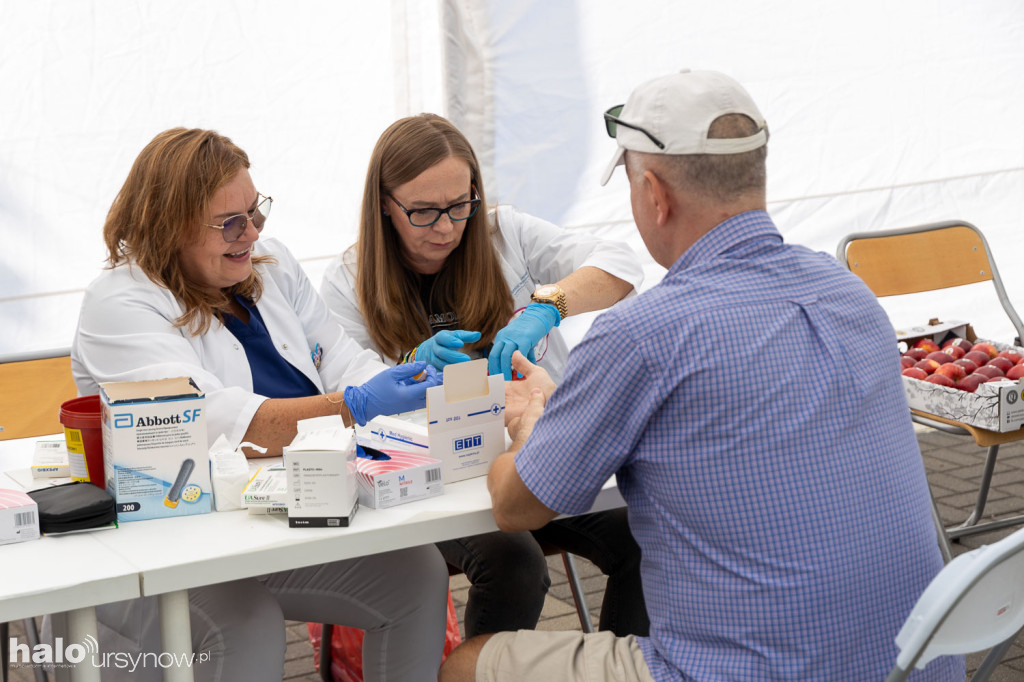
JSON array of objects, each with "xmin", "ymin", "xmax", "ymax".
[{"xmin": 476, "ymin": 630, "xmax": 653, "ymax": 682}]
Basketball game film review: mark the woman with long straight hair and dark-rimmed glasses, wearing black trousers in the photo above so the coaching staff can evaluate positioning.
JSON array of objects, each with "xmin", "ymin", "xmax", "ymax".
[{"xmin": 321, "ymin": 114, "xmax": 648, "ymax": 637}]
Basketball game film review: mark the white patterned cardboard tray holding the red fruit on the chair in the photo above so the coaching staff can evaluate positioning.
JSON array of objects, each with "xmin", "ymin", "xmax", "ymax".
[{"xmin": 896, "ymin": 319, "xmax": 1024, "ymax": 431}]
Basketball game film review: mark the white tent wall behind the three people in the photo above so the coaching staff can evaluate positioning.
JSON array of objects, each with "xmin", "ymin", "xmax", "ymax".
[{"xmin": 0, "ymin": 0, "xmax": 1024, "ymax": 353}]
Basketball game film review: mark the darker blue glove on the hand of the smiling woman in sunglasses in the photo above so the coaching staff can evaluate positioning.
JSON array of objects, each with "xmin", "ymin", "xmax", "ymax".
[{"xmin": 345, "ymin": 363, "xmax": 441, "ymax": 426}]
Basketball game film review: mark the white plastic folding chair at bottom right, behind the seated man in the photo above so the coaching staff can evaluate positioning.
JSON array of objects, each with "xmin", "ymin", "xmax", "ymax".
[{"xmin": 887, "ymin": 522, "xmax": 1024, "ymax": 682}]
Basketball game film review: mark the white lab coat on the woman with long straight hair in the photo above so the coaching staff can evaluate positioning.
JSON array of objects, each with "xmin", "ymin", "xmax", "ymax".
[{"xmin": 321, "ymin": 201, "xmax": 643, "ymax": 381}]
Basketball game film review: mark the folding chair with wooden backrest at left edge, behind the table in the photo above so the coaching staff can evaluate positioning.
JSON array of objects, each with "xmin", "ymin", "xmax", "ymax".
[{"xmin": 0, "ymin": 348, "xmax": 78, "ymax": 682}]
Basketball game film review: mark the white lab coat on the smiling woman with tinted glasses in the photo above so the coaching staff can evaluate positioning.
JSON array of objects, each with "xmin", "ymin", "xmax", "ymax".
[{"xmin": 71, "ymin": 239, "xmax": 386, "ymax": 447}]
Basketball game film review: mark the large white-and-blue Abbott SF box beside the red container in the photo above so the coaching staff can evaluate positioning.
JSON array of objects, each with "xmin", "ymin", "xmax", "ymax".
[{"xmin": 99, "ymin": 377, "xmax": 213, "ymax": 521}]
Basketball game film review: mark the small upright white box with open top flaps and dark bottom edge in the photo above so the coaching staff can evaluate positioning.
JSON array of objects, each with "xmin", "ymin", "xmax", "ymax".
[{"xmin": 285, "ymin": 415, "xmax": 359, "ymax": 528}]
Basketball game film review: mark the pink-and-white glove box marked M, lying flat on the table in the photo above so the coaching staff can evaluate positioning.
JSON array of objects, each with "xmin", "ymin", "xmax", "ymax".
[{"xmin": 355, "ymin": 449, "xmax": 444, "ymax": 509}]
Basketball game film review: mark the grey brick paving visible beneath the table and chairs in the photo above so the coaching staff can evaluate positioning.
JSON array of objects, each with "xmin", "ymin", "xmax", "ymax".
[{"xmin": 10, "ymin": 430, "xmax": 1024, "ymax": 682}]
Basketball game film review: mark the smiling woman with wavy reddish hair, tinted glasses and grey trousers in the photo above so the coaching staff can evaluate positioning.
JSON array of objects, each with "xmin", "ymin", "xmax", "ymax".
[{"xmin": 72, "ymin": 128, "xmax": 447, "ymax": 681}]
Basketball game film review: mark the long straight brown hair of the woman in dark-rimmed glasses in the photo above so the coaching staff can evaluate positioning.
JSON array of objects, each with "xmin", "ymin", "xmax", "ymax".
[{"xmin": 354, "ymin": 114, "xmax": 513, "ymax": 358}]
